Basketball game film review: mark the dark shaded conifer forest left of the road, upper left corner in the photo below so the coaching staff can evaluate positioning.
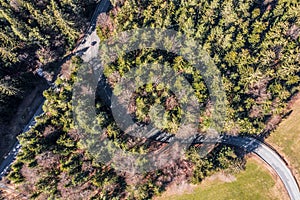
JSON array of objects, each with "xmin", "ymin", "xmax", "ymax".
[{"xmin": 0, "ymin": 0, "xmax": 95, "ymax": 123}]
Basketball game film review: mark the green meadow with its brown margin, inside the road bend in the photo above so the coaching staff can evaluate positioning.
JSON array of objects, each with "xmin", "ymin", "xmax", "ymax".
[{"xmin": 155, "ymin": 156, "xmax": 289, "ymax": 200}]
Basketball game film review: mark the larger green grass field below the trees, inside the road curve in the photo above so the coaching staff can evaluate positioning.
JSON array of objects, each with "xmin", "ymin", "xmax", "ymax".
[{"xmin": 157, "ymin": 158, "xmax": 286, "ymax": 200}]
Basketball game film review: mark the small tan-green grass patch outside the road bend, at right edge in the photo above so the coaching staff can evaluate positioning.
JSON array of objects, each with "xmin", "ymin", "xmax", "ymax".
[{"xmin": 266, "ymin": 99, "xmax": 300, "ymax": 183}]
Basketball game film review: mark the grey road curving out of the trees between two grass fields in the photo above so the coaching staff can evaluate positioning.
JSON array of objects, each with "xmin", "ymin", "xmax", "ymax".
[{"xmin": 146, "ymin": 130, "xmax": 300, "ymax": 200}]
